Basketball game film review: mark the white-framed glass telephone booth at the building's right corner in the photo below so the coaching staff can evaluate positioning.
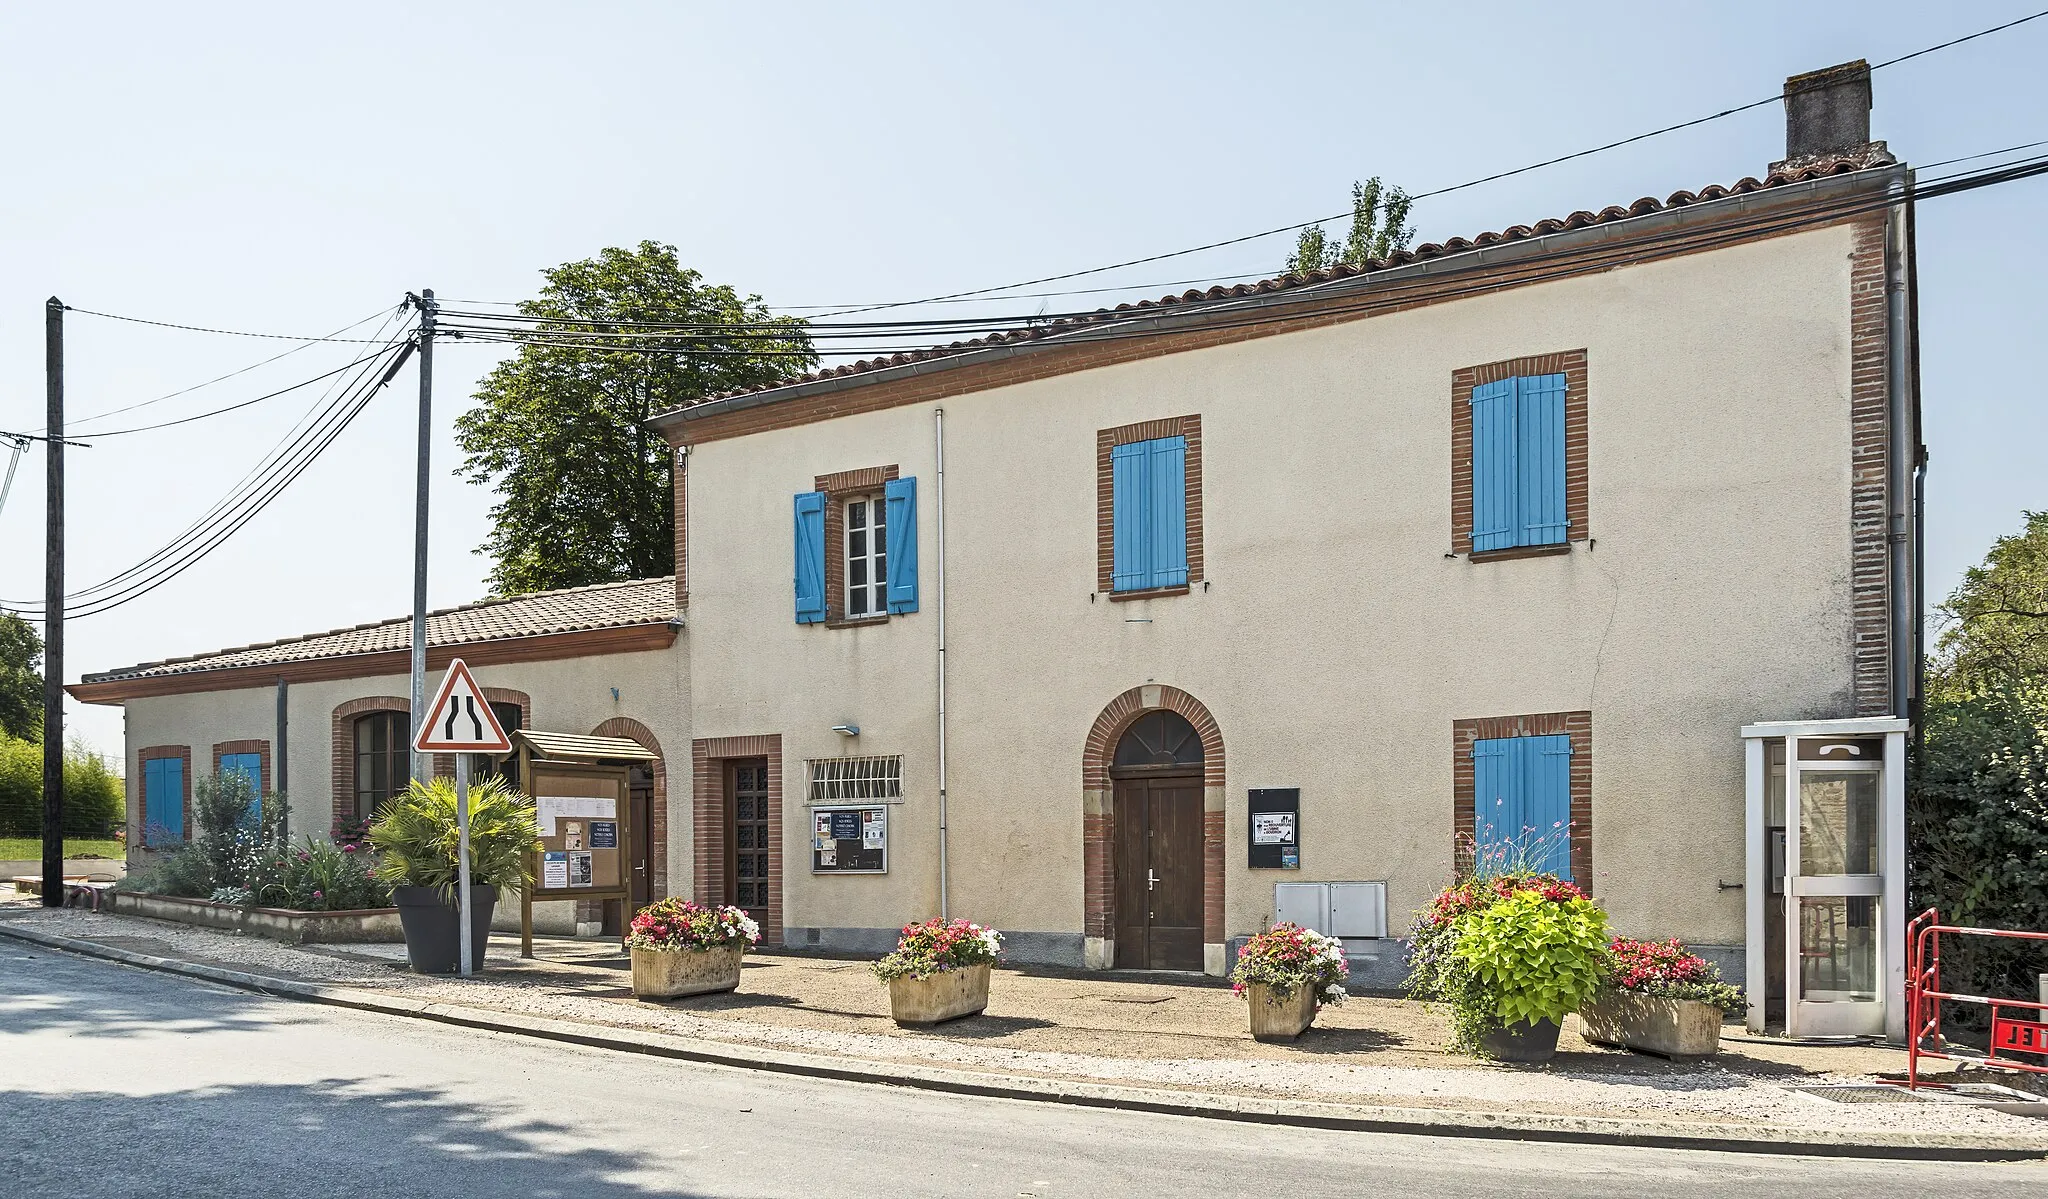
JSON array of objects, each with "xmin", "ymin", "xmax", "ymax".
[{"xmin": 1743, "ymin": 717, "xmax": 1907, "ymax": 1041}]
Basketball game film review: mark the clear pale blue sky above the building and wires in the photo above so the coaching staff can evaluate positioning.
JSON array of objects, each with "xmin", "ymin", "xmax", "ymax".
[{"xmin": 0, "ymin": 0, "xmax": 2048, "ymax": 750}]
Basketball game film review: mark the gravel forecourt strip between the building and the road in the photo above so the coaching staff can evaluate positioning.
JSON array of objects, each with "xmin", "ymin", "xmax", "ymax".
[{"xmin": 0, "ymin": 898, "xmax": 2048, "ymax": 1135}]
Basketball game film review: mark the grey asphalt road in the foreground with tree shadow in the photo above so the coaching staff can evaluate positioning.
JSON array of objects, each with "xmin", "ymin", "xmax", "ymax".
[{"xmin": 0, "ymin": 941, "xmax": 2048, "ymax": 1199}]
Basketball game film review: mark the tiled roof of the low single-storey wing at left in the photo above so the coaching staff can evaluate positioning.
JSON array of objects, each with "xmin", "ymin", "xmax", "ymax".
[{"xmin": 68, "ymin": 576, "xmax": 682, "ymax": 703}]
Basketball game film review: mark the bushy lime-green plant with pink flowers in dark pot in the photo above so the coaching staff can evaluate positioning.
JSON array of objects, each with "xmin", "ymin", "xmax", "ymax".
[{"xmin": 1407, "ymin": 875, "xmax": 1608, "ymax": 1062}]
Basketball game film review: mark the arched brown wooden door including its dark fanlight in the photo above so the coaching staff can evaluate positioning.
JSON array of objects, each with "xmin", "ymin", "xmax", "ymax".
[{"xmin": 1110, "ymin": 711, "xmax": 1204, "ymax": 969}]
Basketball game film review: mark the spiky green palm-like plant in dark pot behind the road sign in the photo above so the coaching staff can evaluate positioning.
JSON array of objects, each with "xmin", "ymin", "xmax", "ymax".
[{"xmin": 369, "ymin": 779, "xmax": 541, "ymax": 974}]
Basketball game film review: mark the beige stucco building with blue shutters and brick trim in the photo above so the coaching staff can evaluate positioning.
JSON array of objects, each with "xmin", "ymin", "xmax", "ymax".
[{"xmin": 76, "ymin": 65, "xmax": 1921, "ymax": 1000}]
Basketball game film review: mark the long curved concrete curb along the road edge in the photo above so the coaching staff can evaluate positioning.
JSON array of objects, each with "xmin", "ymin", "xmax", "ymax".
[{"xmin": 12, "ymin": 922, "xmax": 2048, "ymax": 1162}]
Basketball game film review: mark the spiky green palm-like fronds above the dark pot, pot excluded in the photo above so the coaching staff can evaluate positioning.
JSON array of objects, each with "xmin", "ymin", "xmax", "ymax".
[{"xmin": 371, "ymin": 779, "xmax": 541, "ymax": 900}]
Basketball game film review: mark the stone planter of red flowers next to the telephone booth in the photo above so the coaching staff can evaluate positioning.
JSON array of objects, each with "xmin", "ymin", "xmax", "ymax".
[{"xmin": 1579, "ymin": 937, "xmax": 1747, "ymax": 1058}]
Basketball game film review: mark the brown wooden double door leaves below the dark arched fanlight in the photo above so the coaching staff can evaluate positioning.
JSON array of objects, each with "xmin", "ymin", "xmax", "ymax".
[{"xmin": 1116, "ymin": 777, "xmax": 1202, "ymax": 969}]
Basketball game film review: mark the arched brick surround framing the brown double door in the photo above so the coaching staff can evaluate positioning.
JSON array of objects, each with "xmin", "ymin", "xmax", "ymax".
[{"xmin": 1081, "ymin": 683, "xmax": 1225, "ymax": 963}]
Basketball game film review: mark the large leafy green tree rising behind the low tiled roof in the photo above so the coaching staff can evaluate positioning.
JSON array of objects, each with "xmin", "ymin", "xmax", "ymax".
[{"xmin": 455, "ymin": 242, "xmax": 817, "ymax": 594}]
